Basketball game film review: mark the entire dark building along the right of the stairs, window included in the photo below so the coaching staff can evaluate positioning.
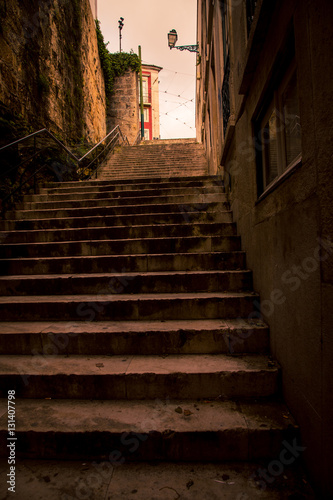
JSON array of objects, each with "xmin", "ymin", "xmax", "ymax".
[{"xmin": 196, "ymin": 0, "xmax": 333, "ymax": 498}]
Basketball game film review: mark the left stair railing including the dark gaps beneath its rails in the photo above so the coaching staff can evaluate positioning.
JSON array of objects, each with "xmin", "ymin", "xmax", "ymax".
[{"xmin": 0, "ymin": 125, "xmax": 129, "ymax": 212}]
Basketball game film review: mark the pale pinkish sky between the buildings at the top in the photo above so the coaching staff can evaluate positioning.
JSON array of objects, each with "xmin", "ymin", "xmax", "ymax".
[{"xmin": 97, "ymin": 0, "xmax": 197, "ymax": 139}]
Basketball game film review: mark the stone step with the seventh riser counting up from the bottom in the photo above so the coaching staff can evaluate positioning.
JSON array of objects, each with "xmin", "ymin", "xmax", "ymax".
[{"xmin": 0, "ymin": 236, "xmax": 240, "ymax": 258}]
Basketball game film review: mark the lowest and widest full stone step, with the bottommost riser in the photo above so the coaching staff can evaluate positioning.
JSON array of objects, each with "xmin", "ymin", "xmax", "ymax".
[{"xmin": 0, "ymin": 396, "xmax": 299, "ymax": 460}]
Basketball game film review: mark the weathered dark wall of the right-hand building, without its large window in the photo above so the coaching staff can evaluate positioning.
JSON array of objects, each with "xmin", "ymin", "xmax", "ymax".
[{"xmin": 198, "ymin": 0, "xmax": 333, "ymax": 498}]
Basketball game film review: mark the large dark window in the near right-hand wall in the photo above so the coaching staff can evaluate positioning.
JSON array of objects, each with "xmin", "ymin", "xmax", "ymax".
[{"xmin": 257, "ymin": 64, "xmax": 302, "ymax": 194}]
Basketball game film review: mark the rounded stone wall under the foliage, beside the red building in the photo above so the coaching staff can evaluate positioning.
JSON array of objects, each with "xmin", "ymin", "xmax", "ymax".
[{"xmin": 107, "ymin": 70, "xmax": 139, "ymax": 144}]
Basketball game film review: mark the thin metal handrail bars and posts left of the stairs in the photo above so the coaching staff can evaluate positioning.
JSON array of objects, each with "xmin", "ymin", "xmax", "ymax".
[{"xmin": 0, "ymin": 125, "xmax": 129, "ymax": 210}]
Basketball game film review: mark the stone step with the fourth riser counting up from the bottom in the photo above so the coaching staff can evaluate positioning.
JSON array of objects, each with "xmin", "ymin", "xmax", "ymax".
[{"xmin": 0, "ymin": 292, "xmax": 259, "ymax": 321}]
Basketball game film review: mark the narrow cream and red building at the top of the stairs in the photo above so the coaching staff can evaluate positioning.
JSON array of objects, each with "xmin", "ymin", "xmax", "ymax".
[{"xmin": 140, "ymin": 64, "xmax": 163, "ymax": 141}]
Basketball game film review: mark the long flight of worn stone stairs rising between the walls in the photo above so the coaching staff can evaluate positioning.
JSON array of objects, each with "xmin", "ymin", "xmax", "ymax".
[{"xmin": 0, "ymin": 145, "xmax": 297, "ymax": 465}]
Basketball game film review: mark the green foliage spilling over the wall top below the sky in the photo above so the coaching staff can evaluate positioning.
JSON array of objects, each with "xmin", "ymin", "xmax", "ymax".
[{"xmin": 96, "ymin": 20, "xmax": 140, "ymax": 97}]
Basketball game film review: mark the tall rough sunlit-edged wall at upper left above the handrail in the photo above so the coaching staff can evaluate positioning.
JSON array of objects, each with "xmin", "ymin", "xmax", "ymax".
[{"xmin": 0, "ymin": 0, "xmax": 106, "ymax": 143}]
